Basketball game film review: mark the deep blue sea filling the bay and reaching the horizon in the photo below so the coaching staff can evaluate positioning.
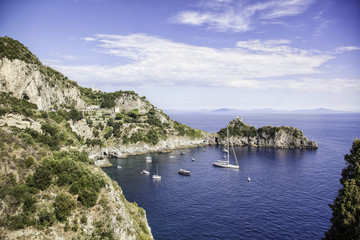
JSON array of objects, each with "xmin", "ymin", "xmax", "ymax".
[{"xmin": 104, "ymin": 114, "xmax": 360, "ymax": 240}]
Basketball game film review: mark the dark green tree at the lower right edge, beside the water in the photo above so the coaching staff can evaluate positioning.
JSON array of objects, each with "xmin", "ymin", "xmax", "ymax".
[{"xmin": 324, "ymin": 139, "xmax": 360, "ymax": 240}]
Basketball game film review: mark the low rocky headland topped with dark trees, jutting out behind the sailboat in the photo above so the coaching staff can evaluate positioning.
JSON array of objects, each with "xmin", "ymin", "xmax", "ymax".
[{"xmin": 217, "ymin": 118, "xmax": 318, "ymax": 149}]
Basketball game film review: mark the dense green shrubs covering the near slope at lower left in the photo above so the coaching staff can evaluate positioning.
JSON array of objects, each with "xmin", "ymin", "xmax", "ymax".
[{"xmin": 0, "ymin": 129, "xmax": 106, "ymax": 230}]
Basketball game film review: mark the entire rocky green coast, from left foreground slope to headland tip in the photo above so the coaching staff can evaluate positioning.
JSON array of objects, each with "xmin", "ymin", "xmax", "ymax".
[{"xmin": 0, "ymin": 37, "xmax": 318, "ymax": 239}]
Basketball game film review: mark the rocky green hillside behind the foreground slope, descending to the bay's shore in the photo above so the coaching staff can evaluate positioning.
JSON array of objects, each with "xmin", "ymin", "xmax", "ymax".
[{"xmin": 0, "ymin": 37, "xmax": 213, "ymax": 157}]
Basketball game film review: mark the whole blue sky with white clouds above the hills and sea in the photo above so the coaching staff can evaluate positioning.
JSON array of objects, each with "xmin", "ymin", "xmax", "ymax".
[{"xmin": 0, "ymin": 0, "xmax": 360, "ymax": 111}]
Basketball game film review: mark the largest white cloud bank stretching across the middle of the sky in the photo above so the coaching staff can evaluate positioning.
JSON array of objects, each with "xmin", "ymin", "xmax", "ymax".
[{"xmin": 50, "ymin": 34, "xmax": 340, "ymax": 93}]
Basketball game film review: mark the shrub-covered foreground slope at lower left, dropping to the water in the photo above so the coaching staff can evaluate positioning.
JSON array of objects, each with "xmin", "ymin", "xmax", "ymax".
[{"xmin": 0, "ymin": 128, "xmax": 152, "ymax": 239}]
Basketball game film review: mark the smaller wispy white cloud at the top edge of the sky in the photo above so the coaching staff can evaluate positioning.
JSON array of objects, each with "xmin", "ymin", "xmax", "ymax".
[{"xmin": 172, "ymin": 0, "xmax": 314, "ymax": 32}]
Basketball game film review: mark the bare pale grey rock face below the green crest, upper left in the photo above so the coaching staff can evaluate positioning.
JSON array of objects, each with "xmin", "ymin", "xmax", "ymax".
[{"xmin": 0, "ymin": 58, "xmax": 85, "ymax": 110}]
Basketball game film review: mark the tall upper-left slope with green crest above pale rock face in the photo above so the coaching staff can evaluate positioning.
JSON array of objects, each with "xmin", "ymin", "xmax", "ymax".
[{"xmin": 0, "ymin": 37, "xmax": 85, "ymax": 110}]
